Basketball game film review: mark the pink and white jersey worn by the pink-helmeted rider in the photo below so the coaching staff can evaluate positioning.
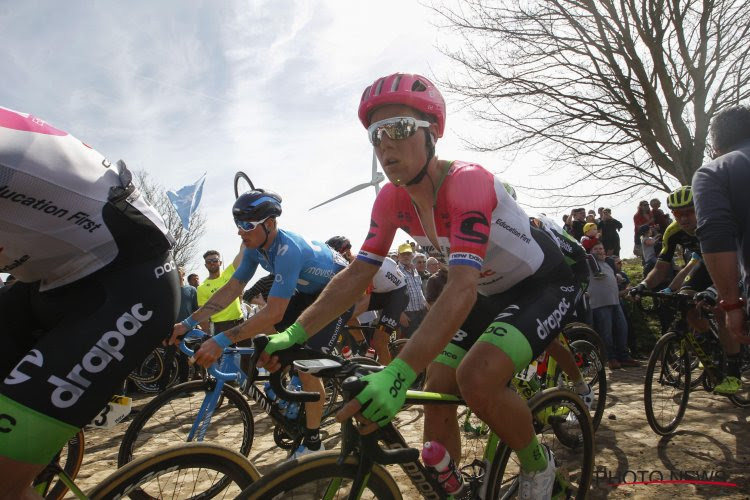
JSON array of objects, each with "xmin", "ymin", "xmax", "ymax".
[{"xmin": 357, "ymin": 161, "xmax": 544, "ymax": 295}]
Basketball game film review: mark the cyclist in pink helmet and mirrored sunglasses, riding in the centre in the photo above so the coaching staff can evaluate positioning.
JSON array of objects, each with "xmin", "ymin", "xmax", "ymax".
[{"xmin": 261, "ymin": 73, "xmax": 578, "ymax": 498}]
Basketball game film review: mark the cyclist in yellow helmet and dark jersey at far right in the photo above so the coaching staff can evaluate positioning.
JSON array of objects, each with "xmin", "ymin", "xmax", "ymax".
[{"xmin": 629, "ymin": 186, "xmax": 742, "ymax": 395}]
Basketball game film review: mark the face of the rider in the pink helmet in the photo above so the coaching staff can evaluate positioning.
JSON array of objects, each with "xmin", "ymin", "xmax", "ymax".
[{"xmin": 370, "ymin": 104, "xmax": 435, "ymax": 186}]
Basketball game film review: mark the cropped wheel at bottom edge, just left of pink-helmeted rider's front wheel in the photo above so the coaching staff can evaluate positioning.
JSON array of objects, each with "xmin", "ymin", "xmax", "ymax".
[{"xmin": 88, "ymin": 443, "xmax": 260, "ymax": 500}]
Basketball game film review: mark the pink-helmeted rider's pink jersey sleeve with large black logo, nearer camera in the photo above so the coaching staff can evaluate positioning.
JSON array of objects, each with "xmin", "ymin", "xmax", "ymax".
[{"xmin": 445, "ymin": 165, "xmax": 498, "ymax": 269}]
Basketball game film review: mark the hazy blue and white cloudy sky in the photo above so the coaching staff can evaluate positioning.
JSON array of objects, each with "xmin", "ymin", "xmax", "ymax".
[{"xmin": 0, "ymin": 0, "xmax": 656, "ymax": 284}]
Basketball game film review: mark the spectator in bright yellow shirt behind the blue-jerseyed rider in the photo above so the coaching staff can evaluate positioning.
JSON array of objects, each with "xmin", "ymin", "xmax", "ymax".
[{"xmin": 198, "ymin": 249, "xmax": 243, "ymax": 334}]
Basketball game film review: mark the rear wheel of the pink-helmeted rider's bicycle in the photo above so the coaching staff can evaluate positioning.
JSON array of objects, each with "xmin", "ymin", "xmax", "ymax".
[{"xmin": 486, "ymin": 388, "xmax": 594, "ymax": 499}]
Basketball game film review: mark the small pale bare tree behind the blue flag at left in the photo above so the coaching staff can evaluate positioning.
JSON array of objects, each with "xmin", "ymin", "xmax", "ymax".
[{"xmin": 133, "ymin": 170, "xmax": 206, "ymax": 267}]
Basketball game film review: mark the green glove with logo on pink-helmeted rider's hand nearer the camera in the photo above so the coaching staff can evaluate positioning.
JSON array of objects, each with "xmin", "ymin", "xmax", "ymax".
[{"xmin": 356, "ymin": 358, "xmax": 417, "ymax": 427}]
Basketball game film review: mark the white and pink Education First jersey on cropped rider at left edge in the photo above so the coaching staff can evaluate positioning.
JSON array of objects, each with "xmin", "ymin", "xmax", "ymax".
[{"xmin": 0, "ymin": 107, "xmax": 167, "ymax": 291}]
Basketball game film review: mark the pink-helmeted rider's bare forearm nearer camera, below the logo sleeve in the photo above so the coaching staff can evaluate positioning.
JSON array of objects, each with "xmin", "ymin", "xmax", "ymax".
[{"xmin": 398, "ymin": 265, "xmax": 479, "ymax": 373}]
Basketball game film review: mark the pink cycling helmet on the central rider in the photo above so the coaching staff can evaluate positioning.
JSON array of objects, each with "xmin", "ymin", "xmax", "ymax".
[{"xmin": 359, "ymin": 73, "xmax": 445, "ymax": 137}]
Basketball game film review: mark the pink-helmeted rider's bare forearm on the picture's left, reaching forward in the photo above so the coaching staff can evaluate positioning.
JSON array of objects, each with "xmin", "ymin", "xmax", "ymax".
[{"xmin": 297, "ymin": 260, "xmax": 378, "ymax": 335}]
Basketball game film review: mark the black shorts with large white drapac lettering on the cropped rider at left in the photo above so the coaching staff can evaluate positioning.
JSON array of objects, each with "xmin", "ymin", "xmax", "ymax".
[{"xmin": 0, "ymin": 252, "xmax": 180, "ymax": 464}]
